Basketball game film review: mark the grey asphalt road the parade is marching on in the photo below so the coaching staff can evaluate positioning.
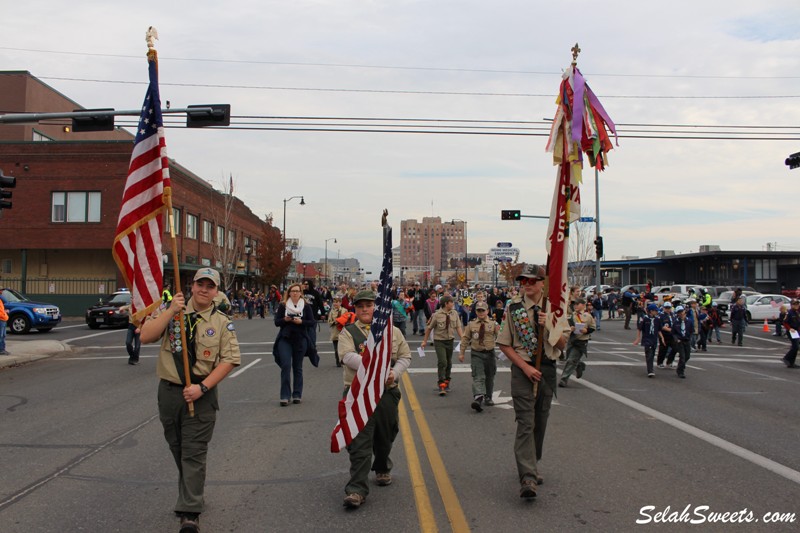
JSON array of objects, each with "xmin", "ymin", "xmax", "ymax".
[{"xmin": 0, "ymin": 319, "xmax": 800, "ymax": 533}]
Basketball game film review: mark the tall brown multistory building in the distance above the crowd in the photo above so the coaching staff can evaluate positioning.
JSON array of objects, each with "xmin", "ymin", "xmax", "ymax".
[{"xmin": 400, "ymin": 217, "xmax": 467, "ymax": 273}]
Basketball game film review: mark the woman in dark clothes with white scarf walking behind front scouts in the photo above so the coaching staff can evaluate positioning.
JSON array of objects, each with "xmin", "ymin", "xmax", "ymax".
[{"xmin": 272, "ymin": 283, "xmax": 317, "ymax": 407}]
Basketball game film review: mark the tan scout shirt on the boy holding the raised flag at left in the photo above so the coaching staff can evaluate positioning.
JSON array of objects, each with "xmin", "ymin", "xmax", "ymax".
[{"xmin": 153, "ymin": 300, "xmax": 242, "ymax": 384}]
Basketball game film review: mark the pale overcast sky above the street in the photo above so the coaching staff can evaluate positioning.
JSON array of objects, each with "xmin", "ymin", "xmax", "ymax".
[{"xmin": 0, "ymin": 0, "xmax": 800, "ymax": 262}]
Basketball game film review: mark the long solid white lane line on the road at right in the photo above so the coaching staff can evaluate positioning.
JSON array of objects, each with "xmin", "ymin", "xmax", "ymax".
[{"xmin": 580, "ymin": 379, "xmax": 800, "ymax": 484}]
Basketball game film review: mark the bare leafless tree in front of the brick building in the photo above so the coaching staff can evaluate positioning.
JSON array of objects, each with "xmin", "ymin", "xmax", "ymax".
[{"xmin": 210, "ymin": 174, "xmax": 245, "ymax": 289}]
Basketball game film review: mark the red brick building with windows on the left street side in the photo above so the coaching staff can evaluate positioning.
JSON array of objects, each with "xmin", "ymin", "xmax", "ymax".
[{"xmin": 0, "ymin": 72, "xmax": 267, "ymax": 314}]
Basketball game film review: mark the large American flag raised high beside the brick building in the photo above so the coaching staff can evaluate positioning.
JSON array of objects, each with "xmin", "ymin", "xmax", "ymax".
[{"xmin": 112, "ymin": 55, "xmax": 172, "ymax": 323}]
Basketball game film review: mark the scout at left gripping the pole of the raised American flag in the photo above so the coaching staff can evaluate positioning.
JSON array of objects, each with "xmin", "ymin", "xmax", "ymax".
[{"xmin": 141, "ymin": 267, "xmax": 241, "ymax": 533}]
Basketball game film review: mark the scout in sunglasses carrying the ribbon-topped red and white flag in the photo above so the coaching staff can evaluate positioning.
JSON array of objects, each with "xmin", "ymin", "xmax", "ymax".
[{"xmin": 497, "ymin": 265, "xmax": 566, "ymax": 498}]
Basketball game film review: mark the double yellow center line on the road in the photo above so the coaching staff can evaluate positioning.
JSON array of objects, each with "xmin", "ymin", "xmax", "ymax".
[{"xmin": 399, "ymin": 374, "xmax": 470, "ymax": 533}]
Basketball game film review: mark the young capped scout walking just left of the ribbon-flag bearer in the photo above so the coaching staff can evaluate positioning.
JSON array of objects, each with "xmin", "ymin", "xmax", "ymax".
[{"xmin": 458, "ymin": 301, "xmax": 500, "ymax": 413}]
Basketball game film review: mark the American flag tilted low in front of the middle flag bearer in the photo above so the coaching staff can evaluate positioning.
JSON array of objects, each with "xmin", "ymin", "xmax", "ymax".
[{"xmin": 331, "ymin": 225, "xmax": 392, "ymax": 453}]
